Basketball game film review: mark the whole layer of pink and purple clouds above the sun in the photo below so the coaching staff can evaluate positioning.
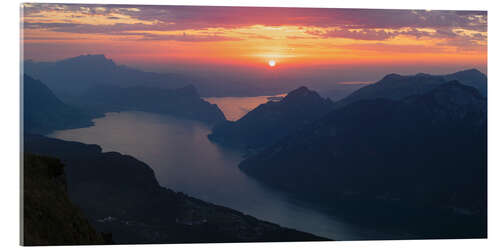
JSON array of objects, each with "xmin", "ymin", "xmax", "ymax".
[{"xmin": 23, "ymin": 4, "xmax": 487, "ymax": 49}]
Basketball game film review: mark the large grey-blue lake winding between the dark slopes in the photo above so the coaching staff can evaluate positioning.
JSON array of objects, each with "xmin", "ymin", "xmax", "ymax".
[{"xmin": 50, "ymin": 95, "xmax": 394, "ymax": 240}]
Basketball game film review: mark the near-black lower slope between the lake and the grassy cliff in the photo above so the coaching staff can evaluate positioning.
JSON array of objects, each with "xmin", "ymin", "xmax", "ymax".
[{"xmin": 24, "ymin": 135, "xmax": 325, "ymax": 243}]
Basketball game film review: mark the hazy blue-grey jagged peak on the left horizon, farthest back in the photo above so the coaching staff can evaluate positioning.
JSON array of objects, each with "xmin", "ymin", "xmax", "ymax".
[{"xmin": 23, "ymin": 55, "xmax": 188, "ymax": 101}]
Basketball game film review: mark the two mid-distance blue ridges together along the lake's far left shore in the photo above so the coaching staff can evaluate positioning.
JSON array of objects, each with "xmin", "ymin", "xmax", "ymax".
[{"xmin": 23, "ymin": 74, "xmax": 225, "ymax": 134}]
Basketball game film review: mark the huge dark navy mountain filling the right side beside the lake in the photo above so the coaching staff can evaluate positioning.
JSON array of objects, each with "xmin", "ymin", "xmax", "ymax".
[{"xmin": 240, "ymin": 81, "xmax": 487, "ymax": 238}]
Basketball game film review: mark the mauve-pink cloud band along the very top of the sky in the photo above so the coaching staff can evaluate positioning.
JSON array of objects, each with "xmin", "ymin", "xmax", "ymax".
[{"xmin": 24, "ymin": 4, "xmax": 487, "ymax": 31}]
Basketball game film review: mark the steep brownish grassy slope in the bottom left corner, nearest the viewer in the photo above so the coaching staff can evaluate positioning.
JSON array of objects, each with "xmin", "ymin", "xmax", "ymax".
[{"xmin": 22, "ymin": 154, "xmax": 110, "ymax": 246}]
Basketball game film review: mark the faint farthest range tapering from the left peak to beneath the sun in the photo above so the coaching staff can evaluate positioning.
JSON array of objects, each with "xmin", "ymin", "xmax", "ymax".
[{"xmin": 23, "ymin": 55, "xmax": 290, "ymax": 98}]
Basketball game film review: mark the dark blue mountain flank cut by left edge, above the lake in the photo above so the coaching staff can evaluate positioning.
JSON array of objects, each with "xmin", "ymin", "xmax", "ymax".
[{"xmin": 22, "ymin": 75, "xmax": 97, "ymax": 134}]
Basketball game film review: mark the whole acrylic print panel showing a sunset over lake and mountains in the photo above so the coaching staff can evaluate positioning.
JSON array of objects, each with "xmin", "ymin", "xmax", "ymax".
[{"xmin": 21, "ymin": 3, "xmax": 488, "ymax": 245}]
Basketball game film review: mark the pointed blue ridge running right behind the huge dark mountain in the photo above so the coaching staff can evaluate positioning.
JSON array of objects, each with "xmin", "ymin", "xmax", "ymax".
[{"xmin": 208, "ymin": 69, "xmax": 487, "ymax": 150}]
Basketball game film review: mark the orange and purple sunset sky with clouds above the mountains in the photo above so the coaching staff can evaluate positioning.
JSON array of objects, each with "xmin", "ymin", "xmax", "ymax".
[{"xmin": 21, "ymin": 3, "xmax": 487, "ymax": 78}]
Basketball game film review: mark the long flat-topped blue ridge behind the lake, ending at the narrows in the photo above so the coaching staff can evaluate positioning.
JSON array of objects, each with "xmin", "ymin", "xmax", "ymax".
[{"xmin": 74, "ymin": 85, "xmax": 226, "ymax": 123}]
